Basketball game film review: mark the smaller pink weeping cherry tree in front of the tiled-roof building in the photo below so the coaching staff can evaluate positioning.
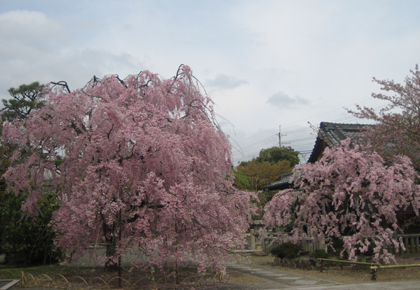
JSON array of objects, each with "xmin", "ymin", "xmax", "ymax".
[{"xmin": 264, "ymin": 139, "xmax": 420, "ymax": 262}]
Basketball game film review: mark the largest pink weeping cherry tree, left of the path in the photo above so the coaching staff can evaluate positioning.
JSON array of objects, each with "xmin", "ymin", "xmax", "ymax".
[{"xmin": 2, "ymin": 66, "xmax": 251, "ymax": 271}]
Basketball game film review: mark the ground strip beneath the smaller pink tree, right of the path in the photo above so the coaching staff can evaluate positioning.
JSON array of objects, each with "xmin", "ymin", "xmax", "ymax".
[{"xmin": 251, "ymin": 254, "xmax": 420, "ymax": 284}]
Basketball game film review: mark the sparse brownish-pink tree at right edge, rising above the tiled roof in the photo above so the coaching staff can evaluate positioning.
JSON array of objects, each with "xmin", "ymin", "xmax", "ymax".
[{"xmin": 349, "ymin": 65, "xmax": 420, "ymax": 171}]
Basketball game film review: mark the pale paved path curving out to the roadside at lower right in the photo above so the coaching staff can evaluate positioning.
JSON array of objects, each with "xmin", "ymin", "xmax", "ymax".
[{"xmin": 225, "ymin": 264, "xmax": 420, "ymax": 290}]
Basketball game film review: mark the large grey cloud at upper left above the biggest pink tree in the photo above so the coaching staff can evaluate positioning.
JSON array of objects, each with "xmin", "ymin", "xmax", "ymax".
[{"xmin": 0, "ymin": 11, "xmax": 144, "ymax": 99}]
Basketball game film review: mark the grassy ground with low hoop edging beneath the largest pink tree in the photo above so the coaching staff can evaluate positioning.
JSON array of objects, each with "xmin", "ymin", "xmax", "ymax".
[{"xmin": 0, "ymin": 265, "xmax": 226, "ymax": 289}]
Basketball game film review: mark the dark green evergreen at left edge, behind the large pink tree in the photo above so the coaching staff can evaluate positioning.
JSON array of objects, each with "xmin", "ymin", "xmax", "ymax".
[{"xmin": 0, "ymin": 82, "xmax": 60, "ymax": 265}]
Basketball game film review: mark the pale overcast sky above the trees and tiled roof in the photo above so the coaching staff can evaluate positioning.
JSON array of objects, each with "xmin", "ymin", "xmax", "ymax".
[{"xmin": 0, "ymin": 0, "xmax": 420, "ymax": 164}]
